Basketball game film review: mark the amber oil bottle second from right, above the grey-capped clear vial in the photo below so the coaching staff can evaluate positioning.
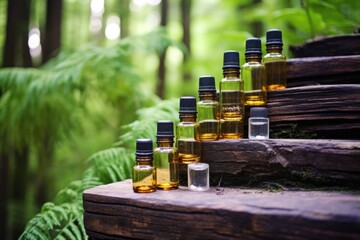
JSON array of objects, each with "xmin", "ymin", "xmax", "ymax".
[{"xmin": 241, "ymin": 38, "xmax": 266, "ymax": 106}]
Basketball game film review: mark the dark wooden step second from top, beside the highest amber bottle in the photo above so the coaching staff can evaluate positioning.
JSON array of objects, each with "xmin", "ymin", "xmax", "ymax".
[{"xmin": 287, "ymin": 55, "xmax": 360, "ymax": 87}]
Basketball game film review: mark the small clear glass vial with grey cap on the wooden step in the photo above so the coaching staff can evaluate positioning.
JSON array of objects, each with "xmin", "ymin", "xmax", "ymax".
[{"xmin": 249, "ymin": 107, "xmax": 269, "ymax": 140}]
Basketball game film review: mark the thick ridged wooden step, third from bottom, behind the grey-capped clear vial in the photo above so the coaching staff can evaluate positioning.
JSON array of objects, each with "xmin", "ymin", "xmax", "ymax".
[{"xmin": 267, "ymin": 84, "xmax": 360, "ymax": 139}]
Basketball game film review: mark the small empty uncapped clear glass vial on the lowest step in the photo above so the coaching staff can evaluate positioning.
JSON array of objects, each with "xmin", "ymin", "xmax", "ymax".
[{"xmin": 188, "ymin": 163, "xmax": 210, "ymax": 192}]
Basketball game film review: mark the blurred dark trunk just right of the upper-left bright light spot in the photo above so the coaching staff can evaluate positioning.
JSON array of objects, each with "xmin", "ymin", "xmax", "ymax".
[{"xmin": 43, "ymin": 0, "xmax": 62, "ymax": 62}]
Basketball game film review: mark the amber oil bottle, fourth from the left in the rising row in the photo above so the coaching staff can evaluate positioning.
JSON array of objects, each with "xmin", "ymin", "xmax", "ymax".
[{"xmin": 197, "ymin": 76, "xmax": 220, "ymax": 141}]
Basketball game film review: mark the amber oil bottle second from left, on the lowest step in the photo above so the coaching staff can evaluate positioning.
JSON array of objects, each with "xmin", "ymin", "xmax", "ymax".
[{"xmin": 154, "ymin": 120, "xmax": 179, "ymax": 190}]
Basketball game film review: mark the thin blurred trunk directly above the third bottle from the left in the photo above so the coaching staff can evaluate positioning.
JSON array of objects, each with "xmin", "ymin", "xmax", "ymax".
[{"xmin": 181, "ymin": 0, "xmax": 191, "ymax": 81}]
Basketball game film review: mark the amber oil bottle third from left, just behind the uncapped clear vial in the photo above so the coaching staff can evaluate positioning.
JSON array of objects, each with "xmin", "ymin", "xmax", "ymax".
[{"xmin": 176, "ymin": 97, "xmax": 201, "ymax": 164}]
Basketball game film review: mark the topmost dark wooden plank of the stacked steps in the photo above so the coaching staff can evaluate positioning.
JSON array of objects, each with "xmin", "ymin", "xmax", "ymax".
[{"xmin": 290, "ymin": 34, "xmax": 360, "ymax": 57}]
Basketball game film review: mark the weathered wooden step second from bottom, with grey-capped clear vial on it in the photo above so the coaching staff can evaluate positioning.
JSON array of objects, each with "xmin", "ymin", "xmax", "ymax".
[{"xmin": 201, "ymin": 139, "xmax": 360, "ymax": 188}]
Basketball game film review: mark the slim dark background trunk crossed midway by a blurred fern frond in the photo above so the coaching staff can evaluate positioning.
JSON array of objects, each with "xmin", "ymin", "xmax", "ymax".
[{"xmin": 156, "ymin": 0, "xmax": 168, "ymax": 98}]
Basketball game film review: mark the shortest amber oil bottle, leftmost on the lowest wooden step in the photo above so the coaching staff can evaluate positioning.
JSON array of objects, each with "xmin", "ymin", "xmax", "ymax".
[{"xmin": 132, "ymin": 139, "xmax": 156, "ymax": 193}]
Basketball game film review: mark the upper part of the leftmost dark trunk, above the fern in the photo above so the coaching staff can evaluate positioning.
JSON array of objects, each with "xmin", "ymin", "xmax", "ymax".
[{"xmin": 2, "ymin": 0, "xmax": 32, "ymax": 67}]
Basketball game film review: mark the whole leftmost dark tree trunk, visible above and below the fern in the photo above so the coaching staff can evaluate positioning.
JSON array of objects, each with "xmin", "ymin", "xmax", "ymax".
[{"xmin": 0, "ymin": 0, "xmax": 32, "ymax": 239}]
